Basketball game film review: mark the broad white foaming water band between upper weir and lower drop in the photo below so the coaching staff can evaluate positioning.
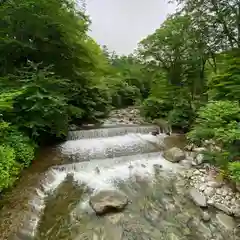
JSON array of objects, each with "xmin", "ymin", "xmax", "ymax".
[{"xmin": 60, "ymin": 129, "xmax": 165, "ymax": 162}]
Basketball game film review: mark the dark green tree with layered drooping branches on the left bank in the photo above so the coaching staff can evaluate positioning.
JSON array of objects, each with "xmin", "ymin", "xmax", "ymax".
[{"xmin": 10, "ymin": 64, "xmax": 68, "ymax": 139}]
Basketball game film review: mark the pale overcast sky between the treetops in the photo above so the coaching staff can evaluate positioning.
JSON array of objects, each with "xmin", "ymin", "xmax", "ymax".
[{"xmin": 86, "ymin": 0, "xmax": 175, "ymax": 54}]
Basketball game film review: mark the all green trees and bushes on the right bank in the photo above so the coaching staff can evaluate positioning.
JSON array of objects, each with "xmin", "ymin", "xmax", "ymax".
[{"xmin": 139, "ymin": 0, "xmax": 240, "ymax": 183}]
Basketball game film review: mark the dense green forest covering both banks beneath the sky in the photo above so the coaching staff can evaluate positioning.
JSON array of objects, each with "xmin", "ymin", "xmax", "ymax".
[{"xmin": 0, "ymin": 0, "xmax": 240, "ymax": 190}]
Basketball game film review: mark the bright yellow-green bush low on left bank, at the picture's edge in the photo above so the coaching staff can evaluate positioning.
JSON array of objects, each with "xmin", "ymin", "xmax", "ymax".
[{"xmin": 0, "ymin": 145, "xmax": 21, "ymax": 191}]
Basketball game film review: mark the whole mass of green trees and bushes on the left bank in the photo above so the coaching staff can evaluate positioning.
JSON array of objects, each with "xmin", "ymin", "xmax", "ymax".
[{"xmin": 0, "ymin": 0, "xmax": 111, "ymax": 190}]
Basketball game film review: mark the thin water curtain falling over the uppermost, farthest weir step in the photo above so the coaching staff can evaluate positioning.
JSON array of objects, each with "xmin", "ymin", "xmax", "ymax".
[{"xmin": 68, "ymin": 126, "xmax": 158, "ymax": 140}]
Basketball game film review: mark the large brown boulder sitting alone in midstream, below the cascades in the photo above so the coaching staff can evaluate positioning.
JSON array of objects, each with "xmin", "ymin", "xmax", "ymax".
[{"xmin": 89, "ymin": 190, "xmax": 128, "ymax": 215}]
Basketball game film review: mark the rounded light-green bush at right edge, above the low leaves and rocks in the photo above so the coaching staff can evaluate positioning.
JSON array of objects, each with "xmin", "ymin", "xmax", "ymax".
[{"xmin": 188, "ymin": 101, "xmax": 240, "ymax": 148}]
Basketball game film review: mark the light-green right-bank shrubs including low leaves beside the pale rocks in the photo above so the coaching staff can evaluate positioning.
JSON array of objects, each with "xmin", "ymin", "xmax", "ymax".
[{"xmin": 188, "ymin": 101, "xmax": 240, "ymax": 181}]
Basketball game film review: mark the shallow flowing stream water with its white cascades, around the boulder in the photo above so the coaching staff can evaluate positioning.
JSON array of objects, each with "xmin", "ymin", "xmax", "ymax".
[{"xmin": 0, "ymin": 126, "xmax": 239, "ymax": 240}]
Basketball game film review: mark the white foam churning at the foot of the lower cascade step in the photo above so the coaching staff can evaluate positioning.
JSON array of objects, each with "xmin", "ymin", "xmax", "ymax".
[{"xmin": 70, "ymin": 154, "xmax": 181, "ymax": 191}]
